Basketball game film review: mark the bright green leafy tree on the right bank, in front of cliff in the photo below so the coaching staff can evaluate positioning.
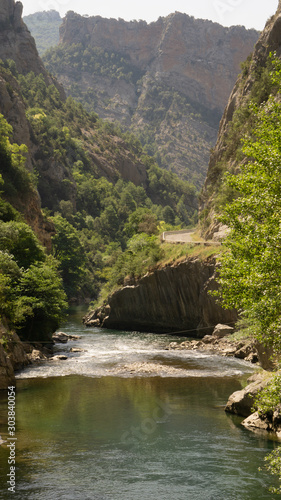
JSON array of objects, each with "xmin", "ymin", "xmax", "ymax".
[{"xmin": 215, "ymin": 56, "xmax": 281, "ymax": 349}]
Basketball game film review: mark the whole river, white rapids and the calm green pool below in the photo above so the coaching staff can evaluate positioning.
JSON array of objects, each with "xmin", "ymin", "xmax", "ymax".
[{"xmin": 0, "ymin": 310, "xmax": 278, "ymax": 500}]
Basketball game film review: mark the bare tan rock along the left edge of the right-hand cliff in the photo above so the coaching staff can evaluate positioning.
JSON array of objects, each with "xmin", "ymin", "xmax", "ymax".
[{"xmin": 200, "ymin": 1, "xmax": 281, "ymax": 239}]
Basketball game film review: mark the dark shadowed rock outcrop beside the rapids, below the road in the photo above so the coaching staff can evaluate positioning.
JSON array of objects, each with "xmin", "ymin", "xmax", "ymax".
[{"xmin": 85, "ymin": 257, "xmax": 237, "ymax": 337}]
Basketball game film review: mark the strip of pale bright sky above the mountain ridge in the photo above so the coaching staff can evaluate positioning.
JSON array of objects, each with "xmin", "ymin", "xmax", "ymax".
[{"xmin": 22, "ymin": 0, "xmax": 278, "ymax": 30}]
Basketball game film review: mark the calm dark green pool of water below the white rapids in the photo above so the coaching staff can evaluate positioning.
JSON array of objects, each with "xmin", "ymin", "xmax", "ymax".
[{"xmin": 1, "ymin": 376, "xmax": 274, "ymax": 500}]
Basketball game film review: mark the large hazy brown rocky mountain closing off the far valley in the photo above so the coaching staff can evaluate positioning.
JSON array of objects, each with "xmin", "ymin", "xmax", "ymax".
[{"xmin": 45, "ymin": 12, "xmax": 258, "ymax": 187}]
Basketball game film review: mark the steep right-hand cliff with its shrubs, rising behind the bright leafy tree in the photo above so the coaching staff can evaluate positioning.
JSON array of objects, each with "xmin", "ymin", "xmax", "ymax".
[{"xmin": 200, "ymin": 2, "xmax": 281, "ymax": 238}]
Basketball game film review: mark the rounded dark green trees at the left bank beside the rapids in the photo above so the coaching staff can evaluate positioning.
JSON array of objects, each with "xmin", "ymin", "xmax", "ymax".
[{"xmin": 0, "ymin": 229, "xmax": 66, "ymax": 342}]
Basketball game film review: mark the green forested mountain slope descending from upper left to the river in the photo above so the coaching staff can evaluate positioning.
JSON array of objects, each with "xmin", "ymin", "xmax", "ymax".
[{"xmin": 0, "ymin": 0, "xmax": 197, "ymax": 306}]
